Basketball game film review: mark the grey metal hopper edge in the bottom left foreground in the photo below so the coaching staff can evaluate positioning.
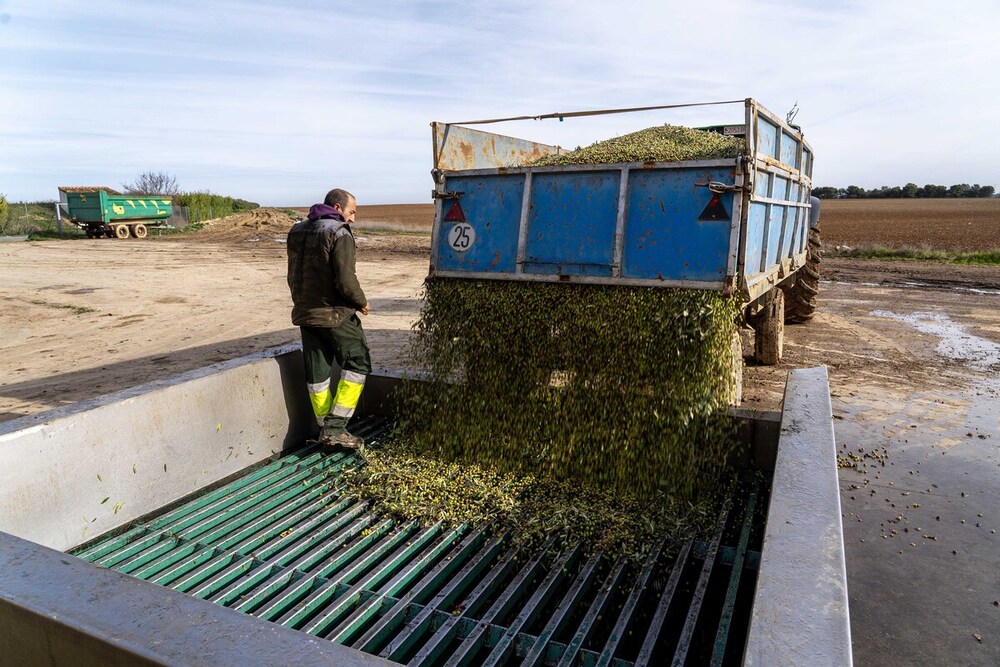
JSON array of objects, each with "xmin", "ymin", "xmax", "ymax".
[{"xmin": 0, "ymin": 532, "xmax": 395, "ymax": 667}]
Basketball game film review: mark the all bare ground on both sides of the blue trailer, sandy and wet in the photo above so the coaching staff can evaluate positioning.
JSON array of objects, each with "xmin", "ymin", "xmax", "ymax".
[{"xmin": 0, "ymin": 205, "xmax": 1000, "ymax": 665}]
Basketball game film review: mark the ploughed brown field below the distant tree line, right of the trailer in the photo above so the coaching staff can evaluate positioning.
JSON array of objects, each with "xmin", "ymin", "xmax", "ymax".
[{"xmin": 820, "ymin": 199, "xmax": 1000, "ymax": 251}]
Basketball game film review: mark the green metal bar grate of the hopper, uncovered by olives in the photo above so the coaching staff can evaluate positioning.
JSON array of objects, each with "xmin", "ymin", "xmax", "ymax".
[{"xmin": 74, "ymin": 418, "xmax": 767, "ymax": 667}]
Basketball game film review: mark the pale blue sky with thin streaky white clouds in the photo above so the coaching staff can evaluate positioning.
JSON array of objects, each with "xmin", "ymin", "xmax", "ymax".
[{"xmin": 0, "ymin": 0, "xmax": 1000, "ymax": 206}]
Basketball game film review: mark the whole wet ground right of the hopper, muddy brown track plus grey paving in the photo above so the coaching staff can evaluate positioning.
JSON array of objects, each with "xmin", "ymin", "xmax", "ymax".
[{"xmin": 748, "ymin": 282, "xmax": 1000, "ymax": 665}]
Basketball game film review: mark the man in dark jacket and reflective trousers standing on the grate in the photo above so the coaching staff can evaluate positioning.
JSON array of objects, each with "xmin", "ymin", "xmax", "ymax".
[{"xmin": 288, "ymin": 189, "xmax": 372, "ymax": 451}]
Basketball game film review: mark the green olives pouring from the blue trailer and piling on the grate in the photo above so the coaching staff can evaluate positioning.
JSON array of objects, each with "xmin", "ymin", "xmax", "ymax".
[{"xmin": 351, "ymin": 279, "xmax": 737, "ymax": 556}]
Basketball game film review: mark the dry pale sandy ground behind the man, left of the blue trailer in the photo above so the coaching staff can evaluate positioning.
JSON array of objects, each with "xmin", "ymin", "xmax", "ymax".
[{"xmin": 0, "ymin": 237, "xmax": 427, "ymax": 421}]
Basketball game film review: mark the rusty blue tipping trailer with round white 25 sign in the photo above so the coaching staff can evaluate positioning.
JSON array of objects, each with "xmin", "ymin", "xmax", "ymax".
[{"xmin": 430, "ymin": 98, "xmax": 820, "ymax": 364}]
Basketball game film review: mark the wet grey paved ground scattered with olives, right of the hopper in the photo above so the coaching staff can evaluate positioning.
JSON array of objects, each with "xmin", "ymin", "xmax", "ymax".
[{"xmin": 834, "ymin": 379, "xmax": 1000, "ymax": 665}]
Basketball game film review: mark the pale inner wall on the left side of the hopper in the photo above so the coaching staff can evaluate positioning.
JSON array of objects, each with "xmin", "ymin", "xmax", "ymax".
[{"xmin": 0, "ymin": 347, "xmax": 314, "ymax": 550}]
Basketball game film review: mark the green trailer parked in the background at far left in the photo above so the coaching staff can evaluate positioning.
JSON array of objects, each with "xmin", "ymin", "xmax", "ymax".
[{"xmin": 59, "ymin": 187, "xmax": 173, "ymax": 239}]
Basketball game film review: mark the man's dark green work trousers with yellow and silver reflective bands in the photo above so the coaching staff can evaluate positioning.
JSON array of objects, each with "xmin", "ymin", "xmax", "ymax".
[{"xmin": 299, "ymin": 315, "xmax": 372, "ymax": 436}]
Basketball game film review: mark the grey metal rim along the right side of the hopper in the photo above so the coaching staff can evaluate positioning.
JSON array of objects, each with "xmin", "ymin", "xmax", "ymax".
[{"xmin": 743, "ymin": 366, "xmax": 853, "ymax": 666}]
